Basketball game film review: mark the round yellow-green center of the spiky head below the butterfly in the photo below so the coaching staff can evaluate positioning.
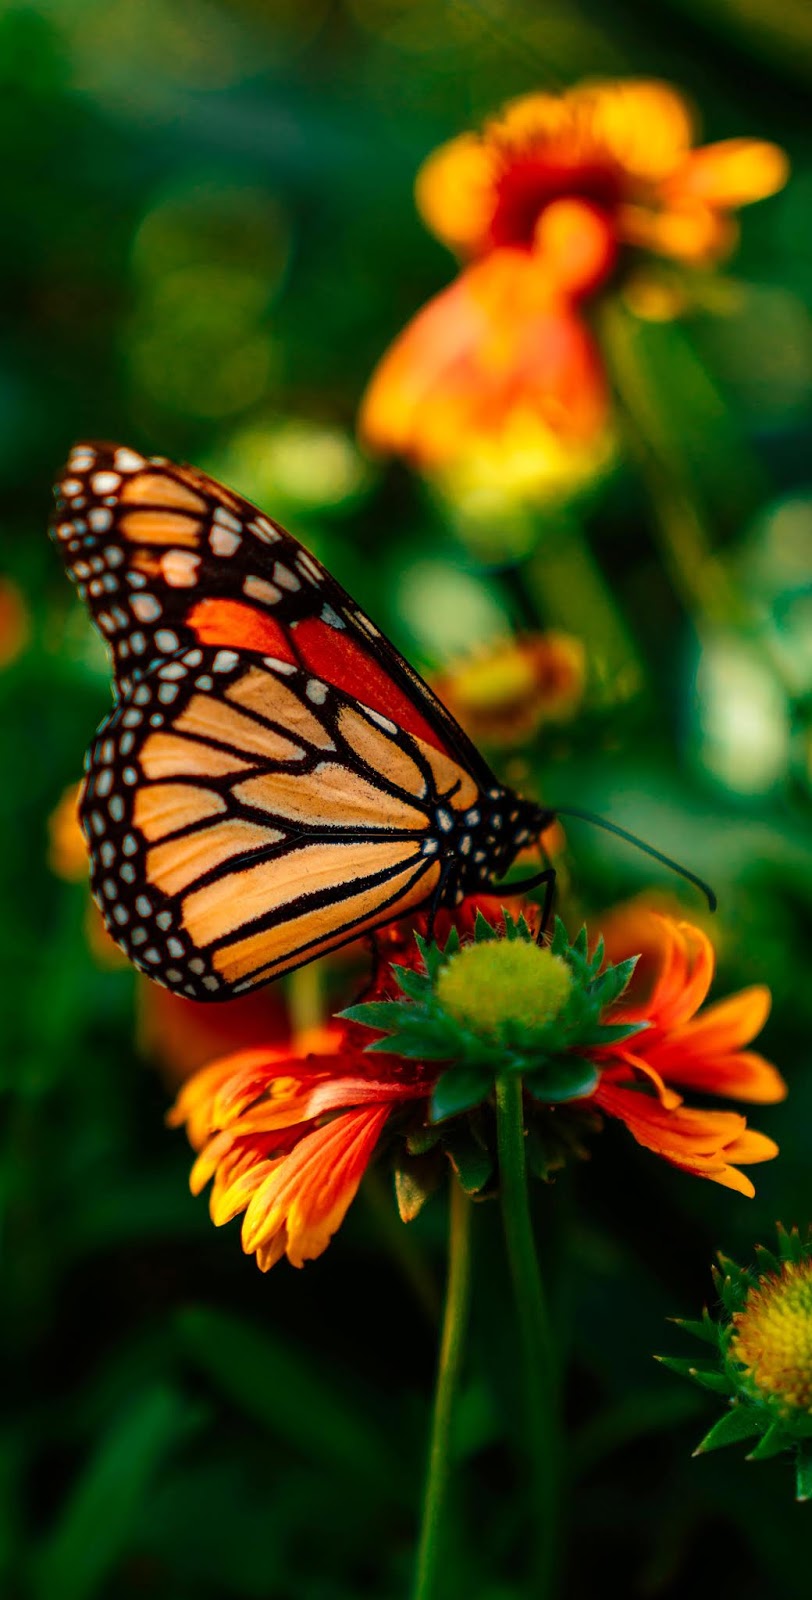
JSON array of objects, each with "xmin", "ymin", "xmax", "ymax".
[{"xmin": 436, "ymin": 939, "xmax": 572, "ymax": 1040}]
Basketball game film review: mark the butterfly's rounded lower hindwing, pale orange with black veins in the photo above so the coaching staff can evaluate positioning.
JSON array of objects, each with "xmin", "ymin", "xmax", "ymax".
[{"xmin": 80, "ymin": 646, "xmax": 495, "ymax": 998}]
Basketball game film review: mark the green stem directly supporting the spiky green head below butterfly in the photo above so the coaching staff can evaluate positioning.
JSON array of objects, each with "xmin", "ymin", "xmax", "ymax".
[{"xmin": 496, "ymin": 1074, "xmax": 561, "ymax": 1600}]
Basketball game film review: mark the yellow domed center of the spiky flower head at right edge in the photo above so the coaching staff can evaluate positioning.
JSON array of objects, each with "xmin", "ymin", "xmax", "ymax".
[{"xmin": 730, "ymin": 1261, "xmax": 812, "ymax": 1411}]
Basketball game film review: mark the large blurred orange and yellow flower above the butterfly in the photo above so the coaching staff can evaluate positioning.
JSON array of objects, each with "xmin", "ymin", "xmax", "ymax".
[{"xmin": 361, "ymin": 80, "xmax": 786, "ymax": 467}]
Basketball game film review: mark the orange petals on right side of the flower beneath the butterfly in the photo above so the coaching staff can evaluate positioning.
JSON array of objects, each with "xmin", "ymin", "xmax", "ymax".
[{"xmin": 593, "ymin": 910, "xmax": 786, "ymax": 1195}]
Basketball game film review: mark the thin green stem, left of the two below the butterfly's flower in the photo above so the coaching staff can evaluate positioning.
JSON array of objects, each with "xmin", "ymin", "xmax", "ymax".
[{"xmin": 412, "ymin": 1179, "xmax": 472, "ymax": 1600}]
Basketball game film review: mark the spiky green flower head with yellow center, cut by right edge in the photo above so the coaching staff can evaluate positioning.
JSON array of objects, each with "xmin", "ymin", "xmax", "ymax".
[{"xmin": 659, "ymin": 1224, "xmax": 812, "ymax": 1499}]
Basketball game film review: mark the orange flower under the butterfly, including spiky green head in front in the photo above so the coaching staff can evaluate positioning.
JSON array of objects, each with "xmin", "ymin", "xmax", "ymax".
[{"xmin": 169, "ymin": 906, "xmax": 783, "ymax": 1270}]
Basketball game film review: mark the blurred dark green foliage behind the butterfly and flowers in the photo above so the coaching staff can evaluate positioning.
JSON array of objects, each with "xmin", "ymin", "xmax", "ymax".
[{"xmin": 0, "ymin": 0, "xmax": 812, "ymax": 1600}]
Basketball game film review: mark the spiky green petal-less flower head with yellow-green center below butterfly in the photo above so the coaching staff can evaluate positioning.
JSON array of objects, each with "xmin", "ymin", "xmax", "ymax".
[{"xmin": 344, "ymin": 912, "xmax": 646, "ymax": 1122}]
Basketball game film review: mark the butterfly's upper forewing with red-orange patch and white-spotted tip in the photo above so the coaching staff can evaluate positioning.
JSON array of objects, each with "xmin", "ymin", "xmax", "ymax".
[{"xmin": 53, "ymin": 445, "xmax": 492, "ymax": 787}]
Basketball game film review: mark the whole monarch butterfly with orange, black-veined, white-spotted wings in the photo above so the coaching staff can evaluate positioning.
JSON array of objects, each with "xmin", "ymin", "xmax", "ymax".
[{"xmin": 53, "ymin": 445, "xmax": 551, "ymax": 1000}]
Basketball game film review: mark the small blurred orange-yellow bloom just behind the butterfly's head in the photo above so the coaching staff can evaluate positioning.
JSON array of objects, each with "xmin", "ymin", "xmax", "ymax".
[{"xmin": 433, "ymin": 632, "xmax": 587, "ymax": 746}]
